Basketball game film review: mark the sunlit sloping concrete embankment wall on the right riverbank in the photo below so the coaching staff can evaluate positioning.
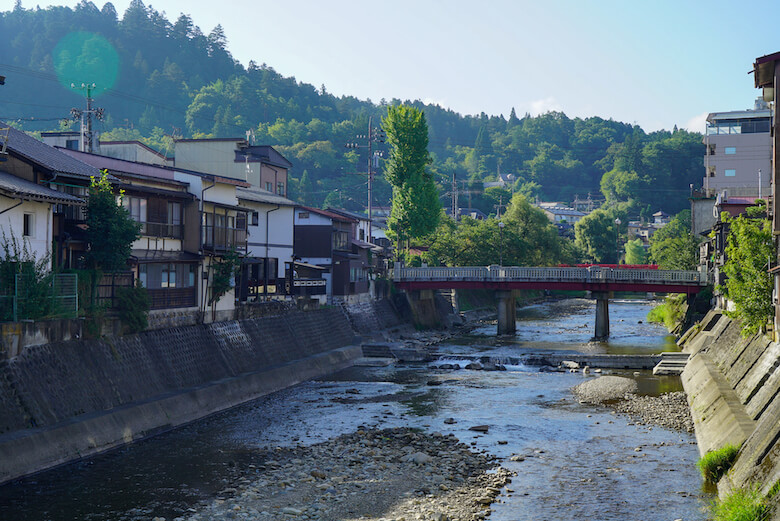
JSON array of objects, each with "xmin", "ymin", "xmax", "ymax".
[{"xmin": 682, "ymin": 311, "xmax": 780, "ymax": 506}]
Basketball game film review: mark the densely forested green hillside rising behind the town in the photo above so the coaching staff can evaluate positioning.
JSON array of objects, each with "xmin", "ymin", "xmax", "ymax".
[{"xmin": 0, "ymin": 0, "xmax": 704, "ymax": 216}]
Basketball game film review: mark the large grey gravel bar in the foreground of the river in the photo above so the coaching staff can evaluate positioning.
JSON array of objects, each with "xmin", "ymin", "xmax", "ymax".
[{"xmin": 180, "ymin": 428, "xmax": 513, "ymax": 521}]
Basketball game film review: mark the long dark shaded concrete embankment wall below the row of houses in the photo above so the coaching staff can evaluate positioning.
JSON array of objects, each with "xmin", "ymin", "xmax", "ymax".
[{"xmin": 0, "ymin": 304, "xmax": 380, "ymax": 483}]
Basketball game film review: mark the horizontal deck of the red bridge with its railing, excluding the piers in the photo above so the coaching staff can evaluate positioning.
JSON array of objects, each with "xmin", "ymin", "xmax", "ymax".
[{"xmin": 393, "ymin": 266, "xmax": 709, "ymax": 293}]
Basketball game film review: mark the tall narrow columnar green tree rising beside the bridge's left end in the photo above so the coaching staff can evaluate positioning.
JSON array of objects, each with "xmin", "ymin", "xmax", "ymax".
[{"xmin": 382, "ymin": 105, "xmax": 441, "ymax": 248}]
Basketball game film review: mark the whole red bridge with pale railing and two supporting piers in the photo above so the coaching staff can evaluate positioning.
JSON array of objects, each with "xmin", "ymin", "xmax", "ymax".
[{"xmin": 393, "ymin": 265, "xmax": 709, "ymax": 338}]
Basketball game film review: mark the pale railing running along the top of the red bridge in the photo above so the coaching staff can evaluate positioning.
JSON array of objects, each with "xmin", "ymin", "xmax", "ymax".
[{"xmin": 393, "ymin": 266, "xmax": 708, "ymax": 286}]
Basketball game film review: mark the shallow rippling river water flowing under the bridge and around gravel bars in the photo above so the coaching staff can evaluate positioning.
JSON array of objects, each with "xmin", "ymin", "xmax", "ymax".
[{"xmin": 0, "ymin": 301, "xmax": 710, "ymax": 521}]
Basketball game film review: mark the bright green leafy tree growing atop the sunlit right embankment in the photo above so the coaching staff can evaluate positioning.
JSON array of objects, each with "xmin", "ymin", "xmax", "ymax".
[{"xmin": 720, "ymin": 201, "xmax": 774, "ymax": 336}]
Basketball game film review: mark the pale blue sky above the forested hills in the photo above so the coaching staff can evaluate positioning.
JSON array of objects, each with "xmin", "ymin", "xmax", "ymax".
[{"xmin": 9, "ymin": 0, "xmax": 780, "ymax": 132}]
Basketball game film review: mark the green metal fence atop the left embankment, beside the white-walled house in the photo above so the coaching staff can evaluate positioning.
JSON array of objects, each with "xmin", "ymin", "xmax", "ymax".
[{"xmin": 0, "ymin": 273, "xmax": 79, "ymax": 322}]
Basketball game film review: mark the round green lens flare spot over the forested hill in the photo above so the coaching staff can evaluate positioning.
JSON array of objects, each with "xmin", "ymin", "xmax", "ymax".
[{"xmin": 52, "ymin": 32, "xmax": 119, "ymax": 97}]
